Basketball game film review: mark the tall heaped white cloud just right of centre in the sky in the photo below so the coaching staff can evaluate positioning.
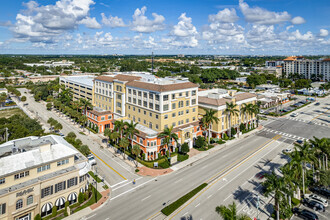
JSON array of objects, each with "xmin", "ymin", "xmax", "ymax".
[{"xmin": 171, "ymin": 13, "xmax": 198, "ymax": 47}]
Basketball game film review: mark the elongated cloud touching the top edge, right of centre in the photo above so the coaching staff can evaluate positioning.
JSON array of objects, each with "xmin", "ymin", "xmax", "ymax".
[{"xmin": 239, "ymin": 0, "xmax": 291, "ymax": 25}]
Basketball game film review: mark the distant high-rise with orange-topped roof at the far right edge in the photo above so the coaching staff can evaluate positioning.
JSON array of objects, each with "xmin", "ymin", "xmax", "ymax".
[{"xmin": 283, "ymin": 56, "xmax": 330, "ymax": 81}]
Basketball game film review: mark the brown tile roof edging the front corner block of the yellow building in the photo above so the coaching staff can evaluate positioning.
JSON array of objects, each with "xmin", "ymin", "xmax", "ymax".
[{"xmin": 126, "ymin": 81, "xmax": 198, "ymax": 92}]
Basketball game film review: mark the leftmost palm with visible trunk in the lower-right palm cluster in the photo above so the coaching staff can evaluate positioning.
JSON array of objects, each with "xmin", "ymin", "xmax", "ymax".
[{"xmin": 262, "ymin": 171, "xmax": 284, "ymax": 220}]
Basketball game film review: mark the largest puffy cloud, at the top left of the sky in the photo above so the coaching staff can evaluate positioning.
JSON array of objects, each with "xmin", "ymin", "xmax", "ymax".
[{"xmin": 11, "ymin": 0, "xmax": 97, "ymax": 42}]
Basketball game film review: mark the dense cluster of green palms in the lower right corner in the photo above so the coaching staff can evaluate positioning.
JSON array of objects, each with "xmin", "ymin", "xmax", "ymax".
[{"xmin": 263, "ymin": 137, "xmax": 330, "ymax": 219}]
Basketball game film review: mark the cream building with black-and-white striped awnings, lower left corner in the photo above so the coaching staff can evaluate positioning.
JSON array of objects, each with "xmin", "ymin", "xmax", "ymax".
[{"xmin": 0, "ymin": 135, "xmax": 89, "ymax": 220}]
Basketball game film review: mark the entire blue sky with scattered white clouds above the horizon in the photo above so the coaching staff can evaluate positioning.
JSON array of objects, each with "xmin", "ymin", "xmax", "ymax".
[{"xmin": 0, "ymin": 0, "xmax": 330, "ymax": 55}]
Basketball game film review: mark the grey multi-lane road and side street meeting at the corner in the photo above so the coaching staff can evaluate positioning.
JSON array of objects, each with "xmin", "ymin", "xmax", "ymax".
[{"xmin": 11, "ymin": 90, "xmax": 330, "ymax": 220}]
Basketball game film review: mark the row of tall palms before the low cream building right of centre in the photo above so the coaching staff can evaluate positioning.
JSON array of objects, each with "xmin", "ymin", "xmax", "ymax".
[{"xmin": 200, "ymin": 102, "xmax": 260, "ymax": 141}]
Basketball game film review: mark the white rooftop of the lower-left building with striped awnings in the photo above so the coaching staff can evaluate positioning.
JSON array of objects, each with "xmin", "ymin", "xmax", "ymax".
[{"xmin": 0, "ymin": 135, "xmax": 82, "ymax": 177}]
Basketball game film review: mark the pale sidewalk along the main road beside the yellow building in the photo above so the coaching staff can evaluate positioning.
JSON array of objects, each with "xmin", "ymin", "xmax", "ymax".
[{"xmin": 171, "ymin": 125, "xmax": 263, "ymax": 171}]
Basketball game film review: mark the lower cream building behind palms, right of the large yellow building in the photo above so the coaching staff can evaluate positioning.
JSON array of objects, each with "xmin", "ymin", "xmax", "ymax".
[{"xmin": 198, "ymin": 89, "xmax": 257, "ymax": 138}]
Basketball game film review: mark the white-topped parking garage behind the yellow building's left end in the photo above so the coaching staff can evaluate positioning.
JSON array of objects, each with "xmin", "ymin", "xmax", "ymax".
[{"xmin": 60, "ymin": 75, "xmax": 94, "ymax": 101}]
